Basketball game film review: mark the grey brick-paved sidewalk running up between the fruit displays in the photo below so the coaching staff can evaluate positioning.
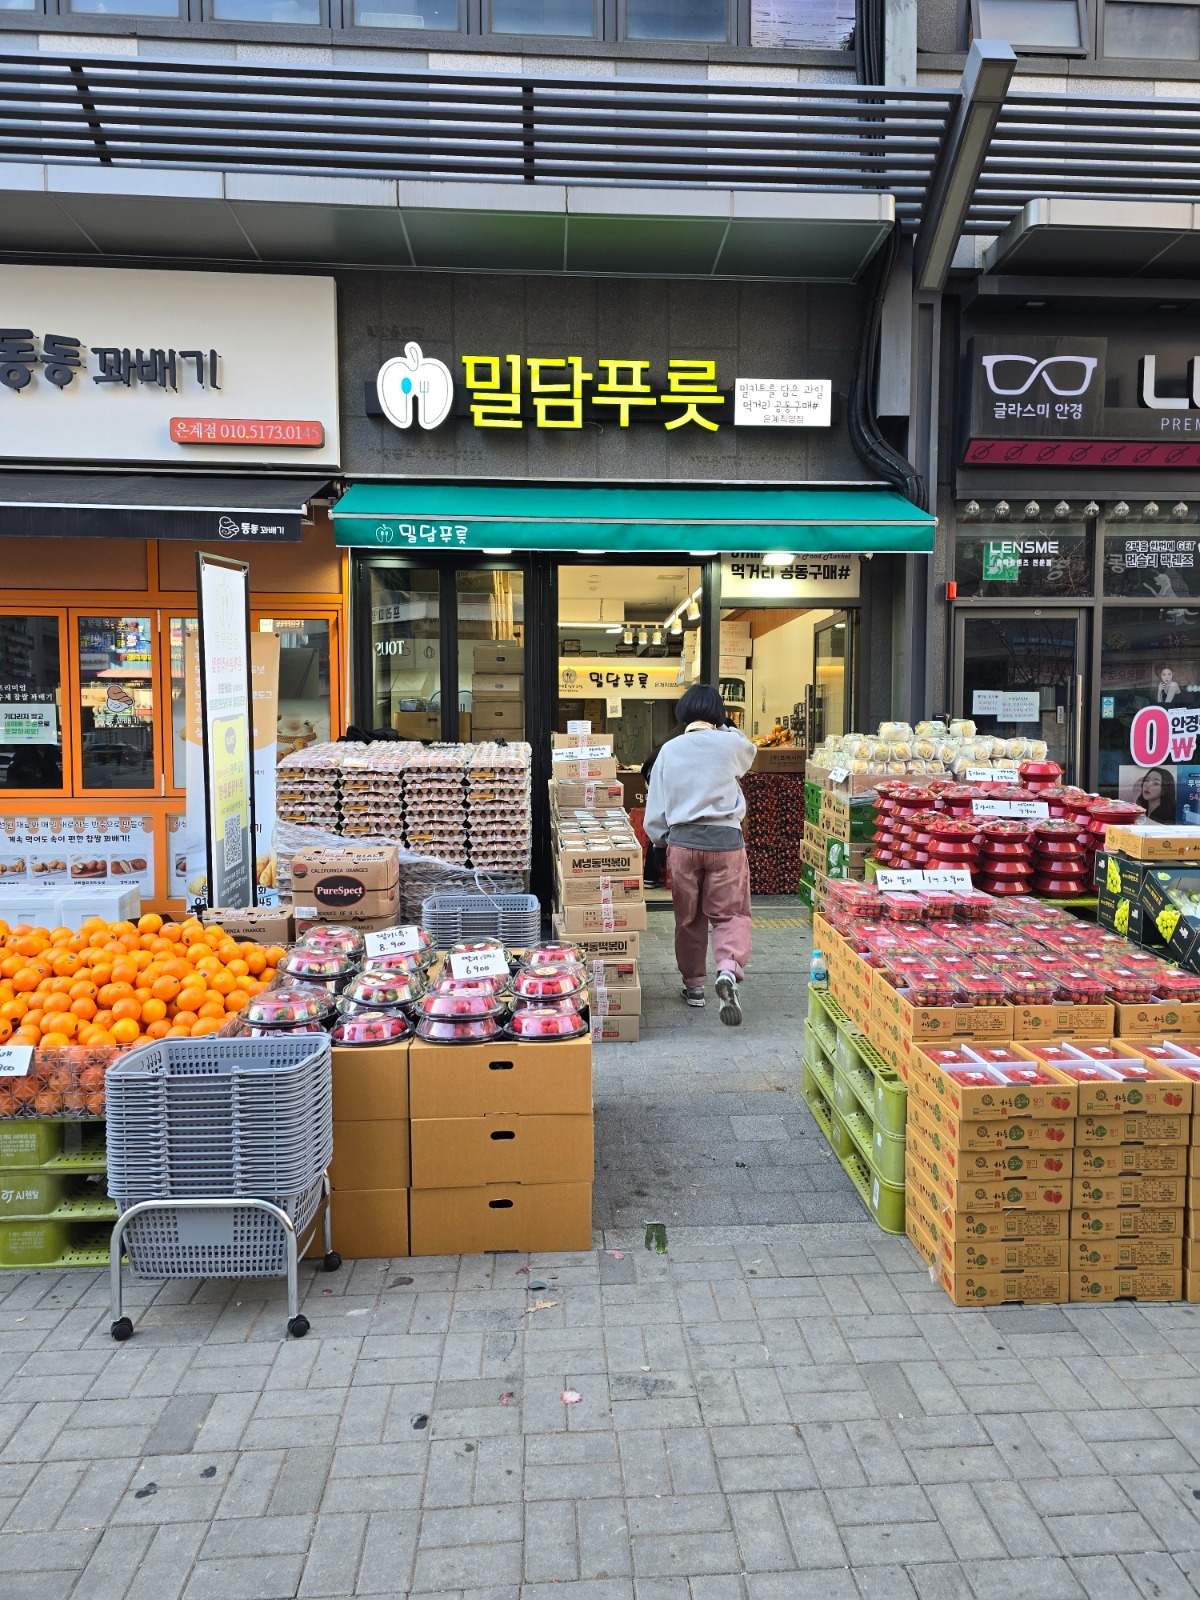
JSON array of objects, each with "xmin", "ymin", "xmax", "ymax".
[{"xmin": 0, "ymin": 909, "xmax": 1200, "ymax": 1600}]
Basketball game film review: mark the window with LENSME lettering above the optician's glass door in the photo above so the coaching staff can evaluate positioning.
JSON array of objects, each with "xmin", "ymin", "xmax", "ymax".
[{"xmin": 954, "ymin": 509, "xmax": 1093, "ymax": 600}]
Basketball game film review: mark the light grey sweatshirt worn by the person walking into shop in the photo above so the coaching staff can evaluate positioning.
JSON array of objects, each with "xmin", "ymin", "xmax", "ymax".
[{"xmin": 645, "ymin": 728, "xmax": 757, "ymax": 850}]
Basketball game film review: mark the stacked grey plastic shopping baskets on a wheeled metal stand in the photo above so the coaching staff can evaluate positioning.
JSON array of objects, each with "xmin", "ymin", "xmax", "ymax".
[{"xmin": 104, "ymin": 1035, "xmax": 341, "ymax": 1339}]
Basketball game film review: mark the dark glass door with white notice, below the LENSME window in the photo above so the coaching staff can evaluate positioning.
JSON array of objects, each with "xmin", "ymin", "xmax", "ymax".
[{"xmin": 955, "ymin": 608, "xmax": 1085, "ymax": 782}]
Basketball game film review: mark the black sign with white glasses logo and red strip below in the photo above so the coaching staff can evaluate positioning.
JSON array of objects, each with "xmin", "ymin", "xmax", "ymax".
[{"xmin": 963, "ymin": 334, "xmax": 1200, "ymax": 469}]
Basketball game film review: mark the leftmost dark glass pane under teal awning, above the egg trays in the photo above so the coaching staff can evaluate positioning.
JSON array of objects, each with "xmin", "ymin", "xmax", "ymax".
[{"xmin": 369, "ymin": 566, "xmax": 442, "ymax": 739}]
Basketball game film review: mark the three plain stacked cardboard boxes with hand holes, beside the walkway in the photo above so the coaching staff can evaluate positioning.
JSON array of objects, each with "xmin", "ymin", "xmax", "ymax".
[{"xmin": 409, "ymin": 1038, "xmax": 594, "ymax": 1256}]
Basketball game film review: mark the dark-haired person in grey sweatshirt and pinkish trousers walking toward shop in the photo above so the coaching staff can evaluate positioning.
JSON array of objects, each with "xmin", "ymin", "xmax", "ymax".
[{"xmin": 645, "ymin": 683, "xmax": 755, "ymax": 1027}]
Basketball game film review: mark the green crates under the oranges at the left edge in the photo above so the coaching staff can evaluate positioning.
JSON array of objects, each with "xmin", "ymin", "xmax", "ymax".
[{"xmin": 0, "ymin": 1117, "xmax": 117, "ymax": 1270}]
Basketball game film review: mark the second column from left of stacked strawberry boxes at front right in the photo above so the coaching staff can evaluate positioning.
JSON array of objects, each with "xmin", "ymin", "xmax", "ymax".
[{"xmin": 1056, "ymin": 1040, "xmax": 1192, "ymax": 1301}]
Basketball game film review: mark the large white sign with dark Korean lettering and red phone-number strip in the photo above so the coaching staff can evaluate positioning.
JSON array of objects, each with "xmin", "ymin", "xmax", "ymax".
[{"xmin": 0, "ymin": 266, "xmax": 339, "ymax": 467}]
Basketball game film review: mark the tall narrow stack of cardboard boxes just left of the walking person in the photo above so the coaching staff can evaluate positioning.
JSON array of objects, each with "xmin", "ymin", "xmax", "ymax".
[{"xmin": 550, "ymin": 731, "xmax": 646, "ymax": 1043}]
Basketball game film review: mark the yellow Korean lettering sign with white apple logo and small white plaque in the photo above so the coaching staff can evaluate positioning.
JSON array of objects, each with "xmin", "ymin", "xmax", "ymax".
[{"xmin": 366, "ymin": 341, "xmax": 832, "ymax": 434}]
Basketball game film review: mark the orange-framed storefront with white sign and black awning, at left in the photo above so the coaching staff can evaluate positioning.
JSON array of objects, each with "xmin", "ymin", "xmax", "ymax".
[{"xmin": 0, "ymin": 266, "xmax": 346, "ymax": 922}]
